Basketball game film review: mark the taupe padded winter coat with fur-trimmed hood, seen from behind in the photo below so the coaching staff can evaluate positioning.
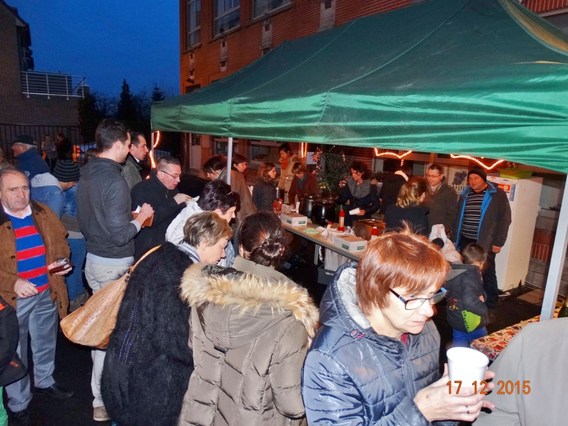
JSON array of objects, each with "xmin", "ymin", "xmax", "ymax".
[{"xmin": 179, "ymin": 262, "xmax": 318, "ymax": 426}]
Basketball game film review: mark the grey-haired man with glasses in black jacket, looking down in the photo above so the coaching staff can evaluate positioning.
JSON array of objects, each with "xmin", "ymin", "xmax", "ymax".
[{"xmin": 131, "ymin": 157, "xmax": 191, "ymax": 261}]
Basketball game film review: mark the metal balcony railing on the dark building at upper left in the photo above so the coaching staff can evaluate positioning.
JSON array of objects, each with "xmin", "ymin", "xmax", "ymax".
[{"xmin": 21, "ymin": 71, "xmax": 87, "ymax": 100}]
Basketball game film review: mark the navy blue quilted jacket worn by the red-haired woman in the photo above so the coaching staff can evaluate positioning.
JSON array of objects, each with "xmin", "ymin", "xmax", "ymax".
[{"xmin": 302, "ymin": 264, "xmax": 453, "ymax": 426}]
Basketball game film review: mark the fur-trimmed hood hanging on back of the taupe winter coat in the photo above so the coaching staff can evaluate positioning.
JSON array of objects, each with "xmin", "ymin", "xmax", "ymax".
[{"xmin": 181, "ymin": 264, "xmax": 319, "ymax": 349}]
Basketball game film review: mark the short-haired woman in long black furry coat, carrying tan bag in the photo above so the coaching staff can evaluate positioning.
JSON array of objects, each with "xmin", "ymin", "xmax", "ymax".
[{"xmin": 101, "ymin": 212, "xmax": 232, "ymax": 426}]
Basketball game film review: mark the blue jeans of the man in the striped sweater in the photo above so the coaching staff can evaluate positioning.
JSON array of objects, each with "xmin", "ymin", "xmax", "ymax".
[{"xmin": 6, "ymin": 290, "xmax": 57, "ymax": 412}]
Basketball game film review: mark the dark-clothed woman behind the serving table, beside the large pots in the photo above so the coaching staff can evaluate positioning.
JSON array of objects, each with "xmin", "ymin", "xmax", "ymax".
[{"xmin": 336, "ymin": 160, "xmax": 379, "ymax": 226}]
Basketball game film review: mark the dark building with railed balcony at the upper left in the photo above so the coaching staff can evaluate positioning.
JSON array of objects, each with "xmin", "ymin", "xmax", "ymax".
[{"xmin": 0, "ymin": 0, "xmax": 85, "ymax": 158}]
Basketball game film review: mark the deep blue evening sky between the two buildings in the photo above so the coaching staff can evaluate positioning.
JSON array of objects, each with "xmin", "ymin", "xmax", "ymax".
[{"xmin": 11, "ymin": 0, "xmax": 179, "ymax": 96}]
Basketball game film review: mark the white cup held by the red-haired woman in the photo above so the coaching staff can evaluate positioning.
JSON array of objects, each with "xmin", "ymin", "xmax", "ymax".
[{"xmin": 446, "ymin": 348, "xmax": 489, "ymax": 389}]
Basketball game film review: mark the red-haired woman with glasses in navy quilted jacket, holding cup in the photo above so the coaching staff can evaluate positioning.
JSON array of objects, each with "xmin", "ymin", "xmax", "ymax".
[{"xmin": 302, "ymin": 229, "xmax": 492, "ymax": 426}]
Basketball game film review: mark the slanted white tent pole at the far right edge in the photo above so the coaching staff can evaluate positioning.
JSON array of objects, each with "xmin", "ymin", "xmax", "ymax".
[{"xmin": 540, "ymin": 179, "xmax": 568, "ymax": 321}]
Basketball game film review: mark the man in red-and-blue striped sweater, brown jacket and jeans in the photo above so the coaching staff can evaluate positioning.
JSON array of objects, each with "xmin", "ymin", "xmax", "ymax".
[{"xmin": 0, "ymin": 167, "xmax": 73, "ymax": 424}]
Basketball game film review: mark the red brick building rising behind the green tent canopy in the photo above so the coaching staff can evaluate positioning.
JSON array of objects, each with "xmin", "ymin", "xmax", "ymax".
[{"xmin": 179, "ymin": 0, "xmax": 568, "ymax": 168}]
